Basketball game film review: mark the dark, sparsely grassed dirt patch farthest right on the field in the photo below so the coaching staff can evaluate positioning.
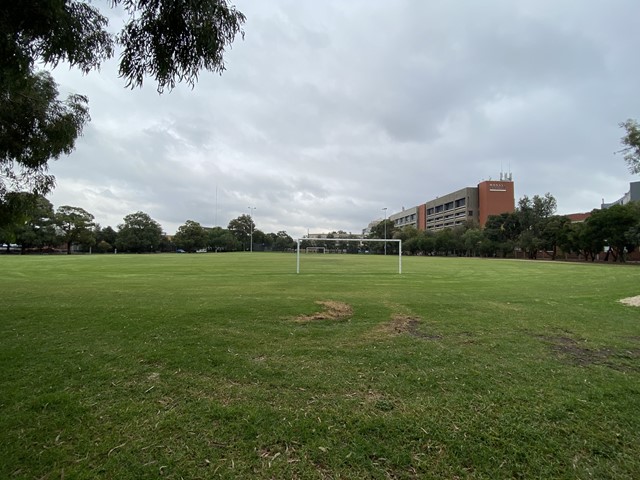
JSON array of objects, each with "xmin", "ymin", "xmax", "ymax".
[{"xmin": 538, "ymin": 335, "xmax": 640, "ymax": 372}]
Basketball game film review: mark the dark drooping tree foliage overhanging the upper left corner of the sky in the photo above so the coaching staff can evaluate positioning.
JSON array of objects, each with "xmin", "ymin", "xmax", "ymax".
[{"xmin": 0, "ymin": 0, "xmax": 245, "ymax": 215}]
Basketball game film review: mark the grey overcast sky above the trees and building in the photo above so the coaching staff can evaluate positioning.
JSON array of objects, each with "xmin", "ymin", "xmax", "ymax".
[{"xmin": 50, "ymin": 0, "xmax": 640, "ymax": 237}]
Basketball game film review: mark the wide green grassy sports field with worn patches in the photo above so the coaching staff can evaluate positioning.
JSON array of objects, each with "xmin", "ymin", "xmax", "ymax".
[{"xmin": 0, "ymin": 252, "xmax": 640, "ymax": 479}]
